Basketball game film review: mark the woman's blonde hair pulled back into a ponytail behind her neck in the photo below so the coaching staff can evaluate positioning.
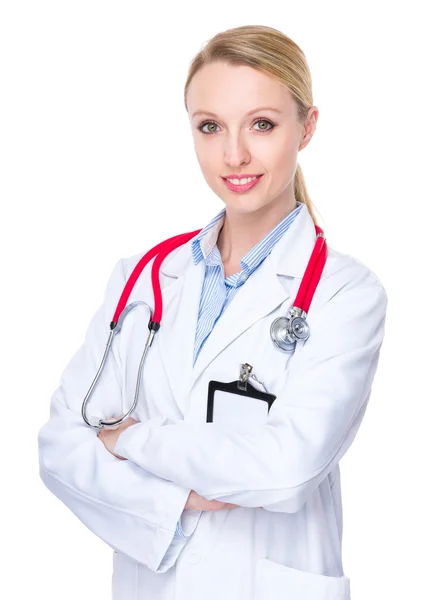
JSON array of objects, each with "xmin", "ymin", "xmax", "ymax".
[{"xmin": 184, "ymin": 25, "xmax": 318, "ymax": 225}]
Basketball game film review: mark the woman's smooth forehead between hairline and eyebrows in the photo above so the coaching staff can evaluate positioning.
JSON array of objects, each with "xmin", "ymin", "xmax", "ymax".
[{"xmin": 187, "ymin": 62, "xmax": 294, "ymax": 118}]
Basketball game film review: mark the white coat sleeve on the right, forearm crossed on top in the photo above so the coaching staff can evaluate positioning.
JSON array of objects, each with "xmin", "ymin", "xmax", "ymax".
[{"xmin": 116, "ymin": 266, "xmax": 387, "ymax": 512}]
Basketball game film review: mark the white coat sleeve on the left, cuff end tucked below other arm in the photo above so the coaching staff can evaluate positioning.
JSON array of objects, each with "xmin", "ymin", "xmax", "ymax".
[{"xmin": 38, "ymin": 261, "xmax": 201, "ymax": 573}]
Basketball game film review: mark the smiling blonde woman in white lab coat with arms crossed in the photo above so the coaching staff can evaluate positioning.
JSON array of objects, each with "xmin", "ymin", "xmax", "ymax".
[{"xmin": 39, "ymin": 26, "xmax": 387, "ymax": 600}]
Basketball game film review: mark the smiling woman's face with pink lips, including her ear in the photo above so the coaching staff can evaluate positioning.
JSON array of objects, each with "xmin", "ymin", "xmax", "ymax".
[{"xmin": 187, "ymin": 62, "xmax": 318, "ymax": 214}]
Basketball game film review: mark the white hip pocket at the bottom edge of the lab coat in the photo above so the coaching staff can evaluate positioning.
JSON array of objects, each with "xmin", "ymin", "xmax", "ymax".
[{"xmin": 254, "ymin": 558, "xmax": 350, "ymax": 600}]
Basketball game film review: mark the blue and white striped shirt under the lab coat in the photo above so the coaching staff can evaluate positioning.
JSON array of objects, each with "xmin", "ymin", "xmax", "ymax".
[{"xmin": 175, "ymin": 202, "xmax": 303, "ymax": 537}]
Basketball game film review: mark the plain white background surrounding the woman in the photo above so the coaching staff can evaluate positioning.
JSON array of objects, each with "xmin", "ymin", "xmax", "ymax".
[{"xmin": 0, "ymin": 0, "xmax": 424, "ymax": 600}]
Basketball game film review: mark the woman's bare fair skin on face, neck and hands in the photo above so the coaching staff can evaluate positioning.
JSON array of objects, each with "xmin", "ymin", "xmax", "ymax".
[{"xmin": 97, "ymin": 62, "xmax": 318, "ymax": 510}]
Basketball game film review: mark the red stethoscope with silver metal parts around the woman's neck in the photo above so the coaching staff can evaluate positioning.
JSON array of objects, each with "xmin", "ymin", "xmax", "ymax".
[{"xmin": 81, "ymin": 225, "xmax": 327, "ymax": 429}]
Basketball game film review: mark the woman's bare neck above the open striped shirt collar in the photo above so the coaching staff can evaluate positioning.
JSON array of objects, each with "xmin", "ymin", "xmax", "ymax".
[{"xmin": 217, "ymin": 198, "xmax": 296, "ymax": 270}]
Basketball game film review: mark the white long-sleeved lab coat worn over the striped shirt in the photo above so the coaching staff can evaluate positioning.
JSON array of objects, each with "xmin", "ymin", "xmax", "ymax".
[{"xmin": 39, "ymin": 206, "xmax": 387, "ymax": 600}]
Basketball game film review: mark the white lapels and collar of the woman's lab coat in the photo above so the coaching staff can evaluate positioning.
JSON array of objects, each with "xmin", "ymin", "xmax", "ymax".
[{"xmin": 158, "ymin": 205, "xmax": 316, "ymax": 415}]
